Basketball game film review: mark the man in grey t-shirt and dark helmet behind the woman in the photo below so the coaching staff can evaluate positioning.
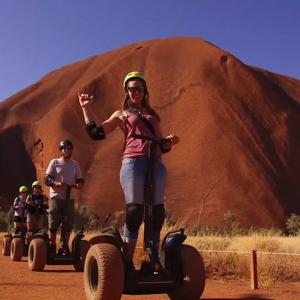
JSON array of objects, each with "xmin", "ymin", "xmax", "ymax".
[{"xmin": 45, "ymin": 140, "xmax": 84, "ymax": 255}]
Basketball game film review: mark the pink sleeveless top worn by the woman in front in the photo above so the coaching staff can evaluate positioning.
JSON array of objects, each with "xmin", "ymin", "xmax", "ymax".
[{"xmin": 122, "ymin": 111, "xmax": 161, "ymax": 159}]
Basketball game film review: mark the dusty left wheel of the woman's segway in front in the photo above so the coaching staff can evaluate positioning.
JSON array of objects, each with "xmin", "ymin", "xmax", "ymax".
[{"xmin": 84, "ymin": 243, "xmax": 124, "ymax": 300}]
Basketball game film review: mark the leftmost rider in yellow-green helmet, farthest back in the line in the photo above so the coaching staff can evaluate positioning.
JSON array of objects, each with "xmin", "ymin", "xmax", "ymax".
[{"xmin": 13, "ymin": 185, "xmax": 28, "ymax": 232}]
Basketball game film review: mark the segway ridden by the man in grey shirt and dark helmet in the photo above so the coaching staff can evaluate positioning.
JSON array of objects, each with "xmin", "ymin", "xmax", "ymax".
[{"xmin": 28, "ymin": 185, "xmax": 89, "ymax": 272}]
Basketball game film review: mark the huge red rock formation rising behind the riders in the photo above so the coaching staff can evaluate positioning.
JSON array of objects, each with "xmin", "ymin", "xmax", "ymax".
[{"xmin": 0, "ymin": 38, "xmax": 300, "ymax": 226}]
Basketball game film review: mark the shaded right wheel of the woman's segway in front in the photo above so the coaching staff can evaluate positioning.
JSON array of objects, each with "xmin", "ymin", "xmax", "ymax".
[{"xmin": 168, "ymin": 245, "xmax": 205, "ymax": 300}]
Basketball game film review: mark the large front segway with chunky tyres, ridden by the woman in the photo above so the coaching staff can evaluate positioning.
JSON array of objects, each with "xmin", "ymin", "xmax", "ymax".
[{"xmin": 84, "ymin": 134, "xmax": 205, "ymax": 300}]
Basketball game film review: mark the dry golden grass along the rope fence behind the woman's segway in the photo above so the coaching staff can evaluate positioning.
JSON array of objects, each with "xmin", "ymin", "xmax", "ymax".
[{"xmin": 0, "ymin": 227, "xmax": 300, "ymax": 287}]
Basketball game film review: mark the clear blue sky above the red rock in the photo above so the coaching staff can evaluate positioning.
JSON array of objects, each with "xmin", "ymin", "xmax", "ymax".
[{"xmin": 0, "ymin": 0, "xmax": 300, "ymax": 101}]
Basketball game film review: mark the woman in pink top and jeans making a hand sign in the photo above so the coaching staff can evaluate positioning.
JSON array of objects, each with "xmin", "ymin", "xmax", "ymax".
[{"xmin": 78, "ymin": 71, "xmax": 179, "ymax": 268}]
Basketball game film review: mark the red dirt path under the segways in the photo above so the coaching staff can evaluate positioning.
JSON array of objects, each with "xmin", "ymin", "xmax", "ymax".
[{"xmin": 0, "ymin": 256, "xmax": 300, "ymax": 300}]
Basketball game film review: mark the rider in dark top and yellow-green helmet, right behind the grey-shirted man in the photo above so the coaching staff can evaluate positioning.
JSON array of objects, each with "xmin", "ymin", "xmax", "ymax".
[{"xmin": 26, "ymin": 180, "xmax": 48, "ymax": 233}]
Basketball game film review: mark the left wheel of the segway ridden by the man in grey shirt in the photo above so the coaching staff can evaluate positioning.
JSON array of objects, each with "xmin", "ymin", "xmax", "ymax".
[{"xmin": 28, "ymin": 238, "xmax": 47, "ymax": 271}]
